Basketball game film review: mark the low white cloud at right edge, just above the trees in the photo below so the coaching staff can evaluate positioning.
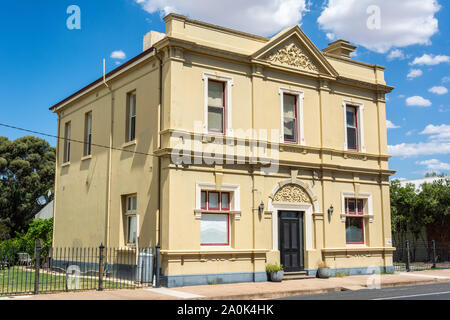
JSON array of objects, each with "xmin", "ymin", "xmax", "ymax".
[{"xmin": 388, "ymin": 124, "xmax": 450, "ymax": 157}]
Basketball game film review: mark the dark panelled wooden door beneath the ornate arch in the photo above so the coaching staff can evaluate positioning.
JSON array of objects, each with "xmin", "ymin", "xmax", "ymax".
[{"xmin": 279, "ymin": 211, "xmax": 304, "ymax": 272}]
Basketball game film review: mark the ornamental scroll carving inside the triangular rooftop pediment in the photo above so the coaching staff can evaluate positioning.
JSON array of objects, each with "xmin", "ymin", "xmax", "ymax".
[{"xmin": 267, "ymin": 43, "xmax": 319, "ymax": 72}]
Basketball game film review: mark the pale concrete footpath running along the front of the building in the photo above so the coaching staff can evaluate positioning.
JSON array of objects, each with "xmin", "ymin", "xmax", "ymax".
[{"xmin": 6, "ymin": 269, "xmax": 450, "ymax": 300}]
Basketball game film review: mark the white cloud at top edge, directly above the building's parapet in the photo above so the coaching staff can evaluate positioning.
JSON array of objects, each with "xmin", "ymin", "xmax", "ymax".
[{"xmin": 135, "ymin": 0, "xmax": 308, "ymax": 36}]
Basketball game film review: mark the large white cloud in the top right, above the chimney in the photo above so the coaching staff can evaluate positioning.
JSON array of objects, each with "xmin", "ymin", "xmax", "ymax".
[{"xmin": 317, "ymin": 0, "xmax": 440, "ymax": 53}]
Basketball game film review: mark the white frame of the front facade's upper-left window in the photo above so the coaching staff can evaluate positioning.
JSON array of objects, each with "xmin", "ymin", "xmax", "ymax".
[{"xmin": 203, "ymin": 72, "xmax": 234, "ymax": 136}]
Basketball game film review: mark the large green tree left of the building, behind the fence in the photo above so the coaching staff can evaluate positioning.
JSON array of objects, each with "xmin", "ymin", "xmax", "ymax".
[{"xmin": 0, "ymin": 136, "xmax": 56, "ymax": 237}]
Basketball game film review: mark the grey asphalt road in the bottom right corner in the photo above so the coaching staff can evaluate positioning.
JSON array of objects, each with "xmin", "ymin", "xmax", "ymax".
[{"xmin": 280, "ymin": 283, "xmax": 450, "ymax": 300}]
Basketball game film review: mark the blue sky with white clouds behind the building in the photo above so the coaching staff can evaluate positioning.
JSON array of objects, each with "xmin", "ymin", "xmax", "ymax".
[{"xmin": 0, "ymin": 0, "xmax": 450, "ymax": 179}]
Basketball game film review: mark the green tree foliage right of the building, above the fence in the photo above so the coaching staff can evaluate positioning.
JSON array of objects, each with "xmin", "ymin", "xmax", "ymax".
[{"xmin": 390, "ymin": 178, "xmax": 450, "ymax": 241}]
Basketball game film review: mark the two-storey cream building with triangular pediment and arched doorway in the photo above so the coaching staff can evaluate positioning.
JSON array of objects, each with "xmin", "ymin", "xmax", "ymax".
[{"xmin": 51, "ymin": 14, "xmax": 394, "ymax": 287}]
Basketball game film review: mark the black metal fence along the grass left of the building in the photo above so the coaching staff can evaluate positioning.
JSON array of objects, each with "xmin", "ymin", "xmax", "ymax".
[{"xmin": 0, "ymin": 245, "xmax": 155, "ymax": 297}]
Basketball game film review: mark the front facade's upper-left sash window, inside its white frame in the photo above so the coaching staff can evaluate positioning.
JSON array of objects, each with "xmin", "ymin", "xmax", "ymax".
[{"xmin": 208, "ymin": 79, "xmax": 226, "ymax": 133}]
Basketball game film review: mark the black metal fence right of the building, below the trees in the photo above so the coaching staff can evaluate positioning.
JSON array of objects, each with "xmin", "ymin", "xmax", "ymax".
[{"xmin": 393, "ymin": 240, "xmax": 450, "ymax": 272}]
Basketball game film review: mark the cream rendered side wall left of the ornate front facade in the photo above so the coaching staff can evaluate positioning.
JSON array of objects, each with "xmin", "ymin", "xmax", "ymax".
[{"xmin": 54, "ymin": 58, "xmax": 159, "ymax": 247}]
